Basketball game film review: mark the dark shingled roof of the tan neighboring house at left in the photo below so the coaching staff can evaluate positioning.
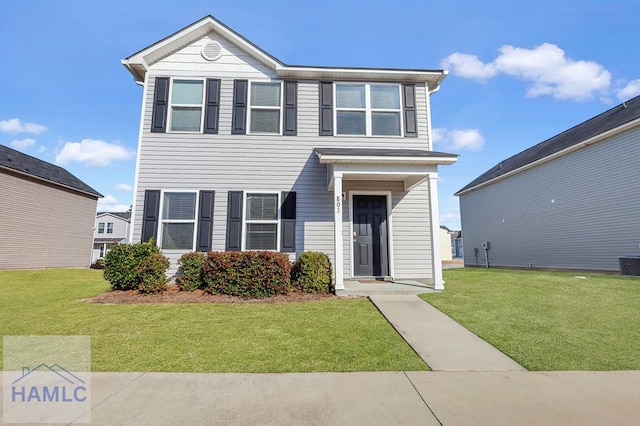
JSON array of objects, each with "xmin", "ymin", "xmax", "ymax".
[{"xmin": 0, "ymin": 145, "xmax": 102, "ymax": 198}]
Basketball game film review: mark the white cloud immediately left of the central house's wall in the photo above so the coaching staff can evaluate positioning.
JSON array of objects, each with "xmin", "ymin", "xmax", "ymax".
[{"xmin": 56, "ymin": 139, "xmax": 135, "ymax": 167}]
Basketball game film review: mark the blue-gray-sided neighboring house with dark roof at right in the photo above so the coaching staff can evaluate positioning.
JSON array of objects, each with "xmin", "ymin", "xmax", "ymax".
[{"xmin": 456, "ymin": 97, "xmax": 640, "ymax": 271}]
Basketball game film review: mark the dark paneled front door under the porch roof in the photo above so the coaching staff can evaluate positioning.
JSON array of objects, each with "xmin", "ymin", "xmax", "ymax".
[{"xmin": 353, "ymin": 195, "xmax": 389, "ymax": 277}]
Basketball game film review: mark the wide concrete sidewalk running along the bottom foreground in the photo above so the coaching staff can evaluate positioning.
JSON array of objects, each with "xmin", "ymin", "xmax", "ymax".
[{"xmin": 5, "ymin": 371, "xmax": 640, "ymax": 425}]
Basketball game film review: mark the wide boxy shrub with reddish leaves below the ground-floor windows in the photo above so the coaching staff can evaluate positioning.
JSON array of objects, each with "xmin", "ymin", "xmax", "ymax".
[{"xmin": 203, "ymin": 251, "xmax": 291, "ymax": 298}]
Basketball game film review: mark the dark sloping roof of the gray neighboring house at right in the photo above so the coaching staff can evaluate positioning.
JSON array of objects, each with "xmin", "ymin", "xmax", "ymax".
[{"xmin": 455, "ymin": 96, "xmax": 640, "ymax": 195}]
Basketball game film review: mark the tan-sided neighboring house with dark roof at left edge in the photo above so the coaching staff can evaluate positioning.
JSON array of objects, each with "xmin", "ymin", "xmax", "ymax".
[{"xmin": 0, "ymin": 145, "xmax": 102, "ymax": 269}]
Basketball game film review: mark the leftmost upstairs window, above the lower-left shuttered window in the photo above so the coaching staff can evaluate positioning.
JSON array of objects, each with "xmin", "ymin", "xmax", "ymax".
[{"xmin": 169, "ymin": 80, "xmax": 204, "ymax": 132}]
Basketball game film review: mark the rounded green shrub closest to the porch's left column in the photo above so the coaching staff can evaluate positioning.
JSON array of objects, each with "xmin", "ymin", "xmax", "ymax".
[{"xmin": 291, "ymin": 251, "xmax": 333, "ymax": 293}]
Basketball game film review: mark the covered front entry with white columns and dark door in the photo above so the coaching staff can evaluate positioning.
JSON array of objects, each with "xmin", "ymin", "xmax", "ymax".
[{"xmin": 314, "ymin": 148, "xmax": 458, "ymax": 290}]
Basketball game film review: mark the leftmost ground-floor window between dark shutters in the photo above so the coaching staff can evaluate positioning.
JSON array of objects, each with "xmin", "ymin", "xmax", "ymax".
[{"xmin": 158, "ymin": 192, "xmax": 196, "ymax": 250}]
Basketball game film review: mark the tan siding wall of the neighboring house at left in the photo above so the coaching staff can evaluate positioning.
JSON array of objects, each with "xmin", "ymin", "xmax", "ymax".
[{"xmin": 0, "ymin": 171, "xmax": 97, "ymax": 269}]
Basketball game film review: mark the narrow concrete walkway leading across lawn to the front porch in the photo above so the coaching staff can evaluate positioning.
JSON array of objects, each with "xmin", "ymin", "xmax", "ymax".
[{"xmin": 369, "ymin": 295, "xmax": 524, "ymax": 371}]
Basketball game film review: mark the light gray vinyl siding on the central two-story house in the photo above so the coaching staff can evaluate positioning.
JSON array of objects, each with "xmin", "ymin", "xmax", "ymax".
[{"xmin": 132, "ymin": 36, "xmax": 438, "ymax": 278}]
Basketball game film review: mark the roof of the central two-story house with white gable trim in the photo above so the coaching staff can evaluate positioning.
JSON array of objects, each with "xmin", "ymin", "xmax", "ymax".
[{"xmin": 122, "ymin": 15, "xmax": 447, "ymax": 90}]
